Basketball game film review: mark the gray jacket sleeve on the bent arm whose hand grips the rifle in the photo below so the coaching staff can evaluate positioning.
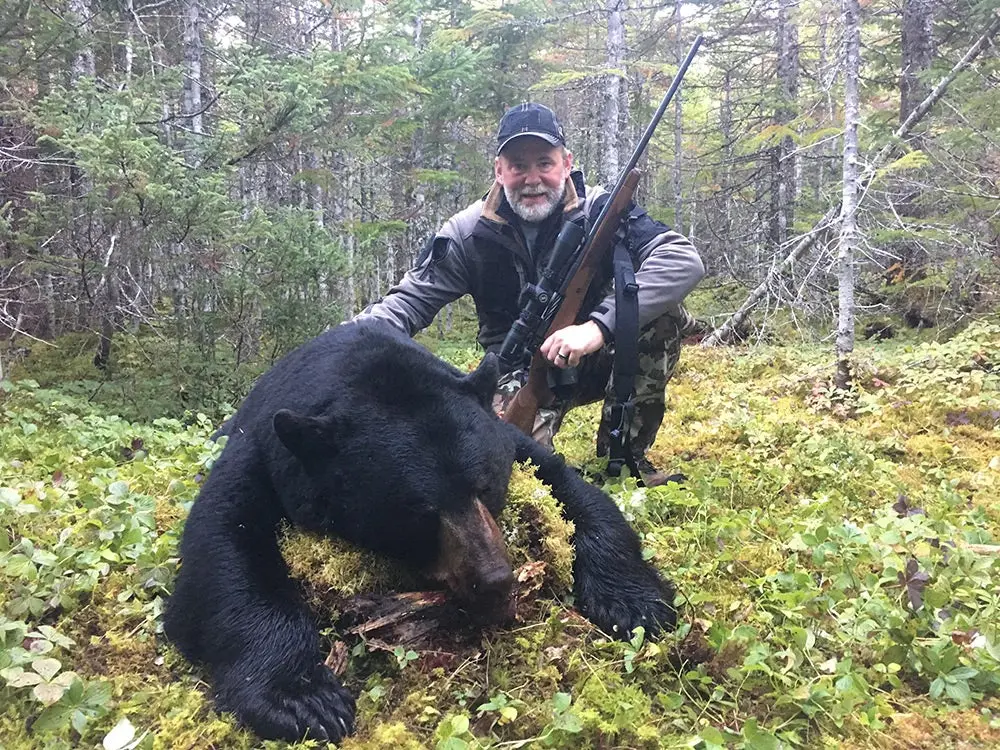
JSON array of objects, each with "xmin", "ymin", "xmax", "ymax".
[{"xmin": 589, "ymin": 207, "xmax": 705, "ymax": 336}]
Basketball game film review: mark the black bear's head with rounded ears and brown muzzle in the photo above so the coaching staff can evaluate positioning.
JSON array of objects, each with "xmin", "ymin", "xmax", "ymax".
[{"xmin": 272, "ymin": 352, "xmax": 514, "ymax": 620}]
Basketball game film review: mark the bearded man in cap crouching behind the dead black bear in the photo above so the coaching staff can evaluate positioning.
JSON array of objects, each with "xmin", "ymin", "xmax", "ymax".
[{"xmin": 359, "ymin": 103, "xmax": 704, "ymax": 486}]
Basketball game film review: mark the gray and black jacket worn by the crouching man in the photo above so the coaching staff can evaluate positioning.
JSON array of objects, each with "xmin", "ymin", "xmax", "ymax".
[{"xmin": 357, "ymin": 171, "xmax": 705, "ymax": 350}]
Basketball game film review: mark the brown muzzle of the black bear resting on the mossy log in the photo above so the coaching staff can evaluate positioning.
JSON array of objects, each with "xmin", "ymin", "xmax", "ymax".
[{"xmin": 429, "ymin": 499, "xmax": 514, "ymax": 623}]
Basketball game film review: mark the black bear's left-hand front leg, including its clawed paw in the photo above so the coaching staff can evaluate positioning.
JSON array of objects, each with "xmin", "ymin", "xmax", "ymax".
[{"xmin": 165, "ymin": 468, "xmax": 355, "ymax": 741}]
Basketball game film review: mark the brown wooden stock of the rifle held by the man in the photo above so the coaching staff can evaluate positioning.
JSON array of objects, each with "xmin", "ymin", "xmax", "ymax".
[{"xmin": 501, "ymin": 169, "xmax": 641, "ymax": 436}]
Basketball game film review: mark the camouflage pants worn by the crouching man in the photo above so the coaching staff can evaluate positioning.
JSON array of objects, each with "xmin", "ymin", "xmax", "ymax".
[{"xmin": 493, "ymin": 315, "xmax": 684, "ymax": 456}]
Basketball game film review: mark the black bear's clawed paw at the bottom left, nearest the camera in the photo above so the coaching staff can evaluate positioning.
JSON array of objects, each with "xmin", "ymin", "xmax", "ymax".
[{"xmin": 219, "ymin": 664, "xmax": 355, "ymax": 742}]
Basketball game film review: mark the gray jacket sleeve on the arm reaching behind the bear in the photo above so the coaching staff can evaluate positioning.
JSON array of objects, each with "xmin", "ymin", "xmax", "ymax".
[{"xmin": 354, "ymin": 234, "xmax": 469, "ymax": 336}]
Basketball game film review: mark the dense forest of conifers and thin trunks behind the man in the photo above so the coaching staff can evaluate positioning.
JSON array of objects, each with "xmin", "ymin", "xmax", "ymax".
[{"xmin": 0, "ymin": 0, "xmax": 1000, "ymax": 416}]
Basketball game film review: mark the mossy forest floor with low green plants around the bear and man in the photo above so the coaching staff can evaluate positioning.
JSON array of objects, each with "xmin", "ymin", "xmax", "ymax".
[{"xmin": 0, "ymin": 320, "xmax": 1000, "ymax": 750}]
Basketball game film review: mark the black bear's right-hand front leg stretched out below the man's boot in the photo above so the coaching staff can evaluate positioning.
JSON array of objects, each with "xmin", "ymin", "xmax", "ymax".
[{"xmin": 512, "ymin": 428, "xmax": 677, "ymax": 638}]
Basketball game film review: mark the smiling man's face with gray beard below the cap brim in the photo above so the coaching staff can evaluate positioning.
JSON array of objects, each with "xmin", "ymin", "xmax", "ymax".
[{"xmin": 494, "ymin": 136, "xmax": 573, "ymax": 222}]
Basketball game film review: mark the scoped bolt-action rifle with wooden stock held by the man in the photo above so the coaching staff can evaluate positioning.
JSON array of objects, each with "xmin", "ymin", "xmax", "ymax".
[{"xmin": 500, "ymin": 35, "xmax": 702, "ymax": 435}]
